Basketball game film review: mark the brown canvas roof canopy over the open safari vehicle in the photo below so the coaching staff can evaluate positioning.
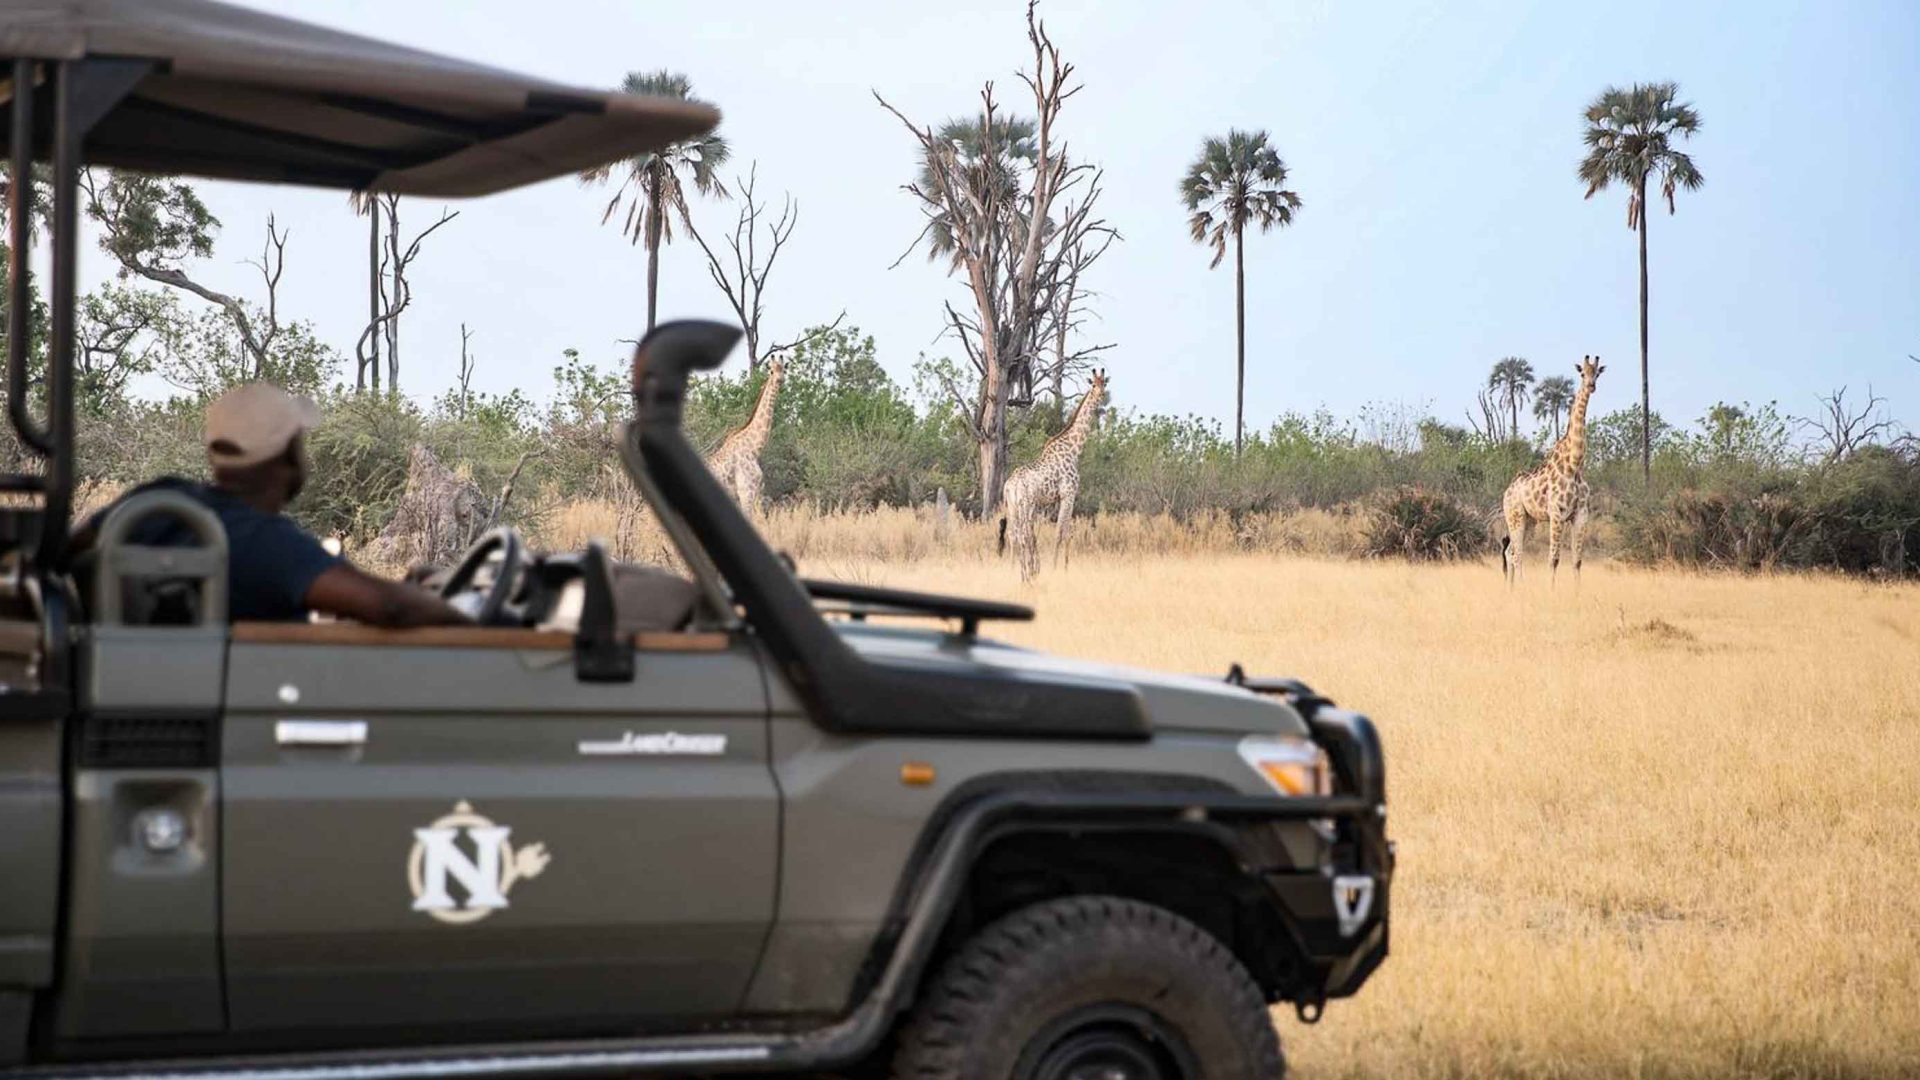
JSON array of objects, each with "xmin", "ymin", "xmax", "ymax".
[{"xmin": 0, "ymin": 0, "xmax": 720, "ymax": 196}]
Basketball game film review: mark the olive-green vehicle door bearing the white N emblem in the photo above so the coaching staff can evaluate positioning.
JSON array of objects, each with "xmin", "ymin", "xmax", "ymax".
[{"xmin": 221, "ymin": 623, "xmax": 780, "ymax": 1038}]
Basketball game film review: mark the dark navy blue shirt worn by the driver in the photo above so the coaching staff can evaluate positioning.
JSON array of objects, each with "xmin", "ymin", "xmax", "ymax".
[{"xmin": 92, "ymin": 477, "xmax": 340, "ymax": 623}]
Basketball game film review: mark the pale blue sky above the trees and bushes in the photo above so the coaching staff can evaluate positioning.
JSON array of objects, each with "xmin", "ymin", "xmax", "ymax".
[{"xmin": 142, "ymin": 0, "xmax": 1920, "ymax": 427}]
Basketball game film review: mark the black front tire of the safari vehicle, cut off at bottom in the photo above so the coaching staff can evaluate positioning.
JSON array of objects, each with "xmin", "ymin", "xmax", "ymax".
[{"xmin": 893, "ymin": 896, "xmax": 1286, "ymax": 1080}]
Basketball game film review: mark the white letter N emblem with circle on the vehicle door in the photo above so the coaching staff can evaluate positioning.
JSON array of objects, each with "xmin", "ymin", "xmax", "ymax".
[{"xmin": 407, "ymin": 801, "xmax": 551, "ymax": 922}]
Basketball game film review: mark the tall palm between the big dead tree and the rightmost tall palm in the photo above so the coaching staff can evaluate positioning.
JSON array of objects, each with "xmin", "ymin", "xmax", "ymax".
[{"xmin": 1181, "ymin": 131, "xmax": 1300, "ymax": 457}]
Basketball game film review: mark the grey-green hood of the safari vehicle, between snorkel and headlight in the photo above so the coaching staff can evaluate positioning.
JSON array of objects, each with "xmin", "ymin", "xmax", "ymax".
[{"xmin": 835, "ymin": 623, "xmax": 1308, "ymax": 736}]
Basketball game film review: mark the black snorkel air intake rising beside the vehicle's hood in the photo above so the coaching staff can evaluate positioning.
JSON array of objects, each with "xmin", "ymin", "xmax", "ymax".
[{"xmin": 628, "ymin": 321, "xmax": 1152, "ymax": 740}]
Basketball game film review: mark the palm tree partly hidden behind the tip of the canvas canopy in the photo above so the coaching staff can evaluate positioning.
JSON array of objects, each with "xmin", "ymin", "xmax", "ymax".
[{"xmin": 580, "ymin": 71, "xmax": 728, "ymax": 331}]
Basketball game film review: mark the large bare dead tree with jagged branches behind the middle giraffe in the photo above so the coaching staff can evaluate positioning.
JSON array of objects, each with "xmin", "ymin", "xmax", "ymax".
[{"xmin": 874, "ymin": 0, "xmax": 1119, "ymax": 513}]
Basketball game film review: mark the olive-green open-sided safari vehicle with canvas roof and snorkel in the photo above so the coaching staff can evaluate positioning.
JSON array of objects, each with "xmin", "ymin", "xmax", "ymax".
[{"xmin": 0, "ymin": 0, "xmax": 1392, "ymax": 1080}]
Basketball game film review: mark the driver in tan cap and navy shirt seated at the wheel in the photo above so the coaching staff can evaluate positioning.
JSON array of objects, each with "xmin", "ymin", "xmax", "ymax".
[{"xmin": 75, "ymin": 382, "xmax": 470, "ymax": 626}]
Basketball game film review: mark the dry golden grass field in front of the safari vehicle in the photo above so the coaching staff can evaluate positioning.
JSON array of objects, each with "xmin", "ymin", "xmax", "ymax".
[{"xmin": 817, "ymin": 549, "xmax": 1920, "ymax": 1078}]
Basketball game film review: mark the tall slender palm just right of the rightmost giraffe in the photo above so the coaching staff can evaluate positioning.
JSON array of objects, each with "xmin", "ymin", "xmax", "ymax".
[{"xmin": 1580, "ymin": 83, "xmax": 1705, "ymax": 484}]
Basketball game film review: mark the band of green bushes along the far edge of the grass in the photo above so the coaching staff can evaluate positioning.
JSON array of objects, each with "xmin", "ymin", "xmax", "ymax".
[{"xmin": 41, "ymin": 329, "xmax": 1920, "ymax": 575}]
